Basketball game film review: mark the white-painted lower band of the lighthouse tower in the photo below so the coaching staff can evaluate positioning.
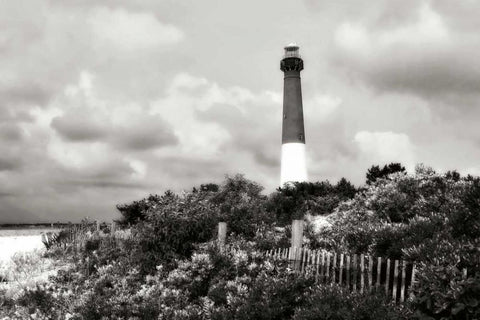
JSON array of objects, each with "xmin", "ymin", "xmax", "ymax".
[{"xmin": 280, "ymin": 142, "xmax": 307, "ymax": 186}]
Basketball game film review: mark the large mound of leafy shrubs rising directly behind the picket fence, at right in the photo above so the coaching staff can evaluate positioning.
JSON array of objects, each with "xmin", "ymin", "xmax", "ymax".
[{"xmin": 317, "ymin": 166, "xmax": 480, "ymax": 263}]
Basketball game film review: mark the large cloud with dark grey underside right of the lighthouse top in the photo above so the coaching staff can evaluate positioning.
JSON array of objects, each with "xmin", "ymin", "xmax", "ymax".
[{"xmin": 334, "ymin": 2, "xmax": 480, "ymax": 98}]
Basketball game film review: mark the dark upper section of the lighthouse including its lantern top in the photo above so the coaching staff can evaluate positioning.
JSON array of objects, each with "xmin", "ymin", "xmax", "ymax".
[{"xmin": 280, "ymin": 44, "xmax": 305, "ymax": 144}]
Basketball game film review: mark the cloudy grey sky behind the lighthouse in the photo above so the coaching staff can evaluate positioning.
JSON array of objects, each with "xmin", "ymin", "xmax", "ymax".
[{"xmin": 0, "ymin": 0, "xmax": 480, "ymax": 223}]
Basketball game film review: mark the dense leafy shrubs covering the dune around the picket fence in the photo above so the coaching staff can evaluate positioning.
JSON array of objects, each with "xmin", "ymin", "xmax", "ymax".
[{"xmin": 0, "ymin": 164, "xmax": 480, "ymax": 320}]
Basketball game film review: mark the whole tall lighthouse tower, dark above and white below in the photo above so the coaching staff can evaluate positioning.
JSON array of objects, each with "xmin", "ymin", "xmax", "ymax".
[{"xmin": 280, "ymin": 43, "xmax": 307, "ymax": 186}]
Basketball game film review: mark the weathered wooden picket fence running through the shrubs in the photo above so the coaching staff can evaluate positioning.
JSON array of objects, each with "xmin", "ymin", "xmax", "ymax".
[{"xmin": 266, "ymin": 248, "xmax": 415, "ymax": 302}]
